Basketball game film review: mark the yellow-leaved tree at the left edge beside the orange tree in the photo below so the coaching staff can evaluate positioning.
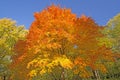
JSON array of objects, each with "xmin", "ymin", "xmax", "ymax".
[{"xmin": 0, "ymin": 18, "xmax": 26, "ymax": 80}]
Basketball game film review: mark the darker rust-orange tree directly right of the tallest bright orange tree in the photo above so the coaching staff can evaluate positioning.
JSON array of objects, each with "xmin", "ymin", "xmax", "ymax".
[{"xmin": 75, "ymin": 15, "xmax": 114, "ymax": 79}]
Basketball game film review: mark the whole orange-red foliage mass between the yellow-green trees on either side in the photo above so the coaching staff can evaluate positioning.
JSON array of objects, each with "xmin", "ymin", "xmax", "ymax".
[{"xmin": 13, "ymin": 5, "xmax": 116, "ymax": 80}]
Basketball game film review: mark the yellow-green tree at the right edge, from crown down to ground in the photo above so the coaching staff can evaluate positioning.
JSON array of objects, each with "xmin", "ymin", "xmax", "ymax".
[{"xmin": 103, "ymin": 14, "xmax": 120, "ymax": 78}]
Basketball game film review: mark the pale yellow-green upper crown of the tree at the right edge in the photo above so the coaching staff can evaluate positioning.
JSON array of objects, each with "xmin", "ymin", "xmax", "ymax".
[{"xmin": 107, "ymin": 14, "xmax": 120, "ymax": 53}]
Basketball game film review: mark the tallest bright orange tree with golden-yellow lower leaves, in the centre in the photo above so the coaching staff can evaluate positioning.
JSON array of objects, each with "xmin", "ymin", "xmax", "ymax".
[{"xmin": 11, "ymin": 5, "xmax": 76, "ymax": 78}]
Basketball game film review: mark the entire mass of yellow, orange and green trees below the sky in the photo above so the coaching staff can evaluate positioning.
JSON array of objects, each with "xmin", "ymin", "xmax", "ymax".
[{"xmin": 0, "ymin": 5, "xmax": 120, "ymax": 80}]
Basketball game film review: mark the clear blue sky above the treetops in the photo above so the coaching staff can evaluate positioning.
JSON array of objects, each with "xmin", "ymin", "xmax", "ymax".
[{"xmin": 0, "ymin": 0, "xmax": 120, "ymax": 29}]
